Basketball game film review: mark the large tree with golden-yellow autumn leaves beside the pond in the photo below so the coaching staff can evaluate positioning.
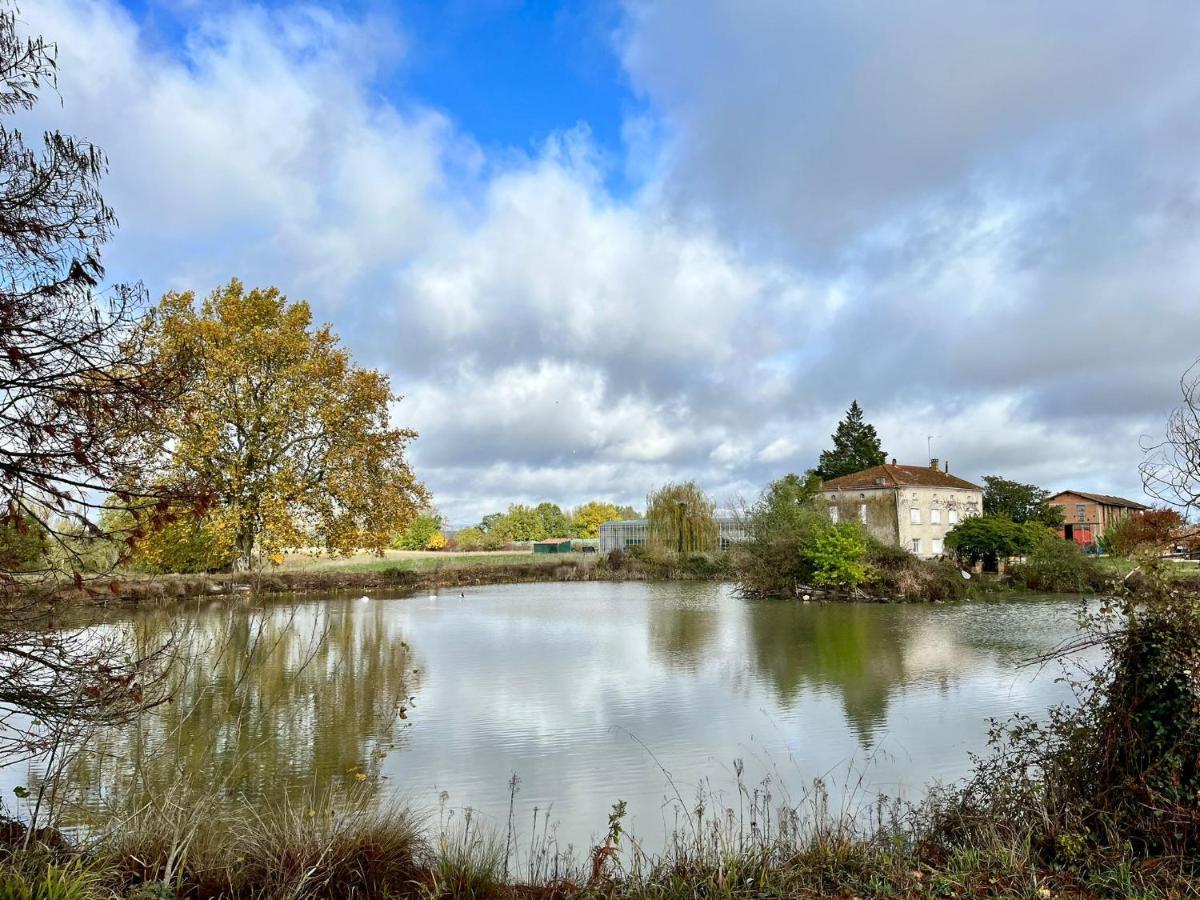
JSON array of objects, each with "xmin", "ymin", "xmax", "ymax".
[{"xmin": 138, "ymin": 280, "xmax": 428, "ymax": 568}]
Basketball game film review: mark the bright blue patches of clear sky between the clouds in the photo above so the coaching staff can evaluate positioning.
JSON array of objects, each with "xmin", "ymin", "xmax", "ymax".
[{"xmin": 122, "ymin": 0, "xmax": 640, "ymax": 175}]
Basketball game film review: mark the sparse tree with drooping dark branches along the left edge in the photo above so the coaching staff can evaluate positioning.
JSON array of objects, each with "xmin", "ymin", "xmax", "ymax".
[{"xmin": 0, "ymin": 4, "xmax": 174, "ymax": 754}]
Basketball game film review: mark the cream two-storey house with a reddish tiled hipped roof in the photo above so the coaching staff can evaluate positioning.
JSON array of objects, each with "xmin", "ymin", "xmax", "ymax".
[{"xmin": 820, "ymin": 460, "xmax": 983, "ymax": 559}]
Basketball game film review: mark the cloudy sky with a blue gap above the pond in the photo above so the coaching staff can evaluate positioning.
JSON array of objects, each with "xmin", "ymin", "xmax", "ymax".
[{"xmin": 16, "ymin": 0, "xmax": 1200, "ymax": 523}]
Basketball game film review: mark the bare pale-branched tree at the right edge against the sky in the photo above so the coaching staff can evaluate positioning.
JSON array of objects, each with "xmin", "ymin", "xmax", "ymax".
[{"xmin": 1141, "ymin": 359, "xmax": 1200, "ymax": 517}]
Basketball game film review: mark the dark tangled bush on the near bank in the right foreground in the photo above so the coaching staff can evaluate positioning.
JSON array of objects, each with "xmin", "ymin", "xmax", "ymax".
[{"xmin": 938, "ymin": 564, "xmax": 1200, "ymax": 859}]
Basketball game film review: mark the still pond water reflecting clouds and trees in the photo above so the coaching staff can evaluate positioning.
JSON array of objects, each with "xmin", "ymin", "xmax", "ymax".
[{"xmin": 11, "ymin": 583, "xmax": 1099, "ymax": 848}]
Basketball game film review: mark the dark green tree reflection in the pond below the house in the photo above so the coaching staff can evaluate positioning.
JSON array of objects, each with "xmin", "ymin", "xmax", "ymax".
[{"xmin": 746, "ymin": 602, "xmax": 905, "ymax": 746}]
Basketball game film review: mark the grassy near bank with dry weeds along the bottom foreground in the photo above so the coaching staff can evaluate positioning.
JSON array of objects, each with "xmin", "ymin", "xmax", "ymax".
[{"xmin": 0, "ymin": 786, "xmax": 1200, "ymax": 900}]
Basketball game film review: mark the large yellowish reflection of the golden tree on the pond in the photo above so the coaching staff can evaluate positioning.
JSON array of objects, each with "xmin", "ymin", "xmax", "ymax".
[{"xmin": 72, "ymin": 600, "xmax": 416, "ymax": 816}]
